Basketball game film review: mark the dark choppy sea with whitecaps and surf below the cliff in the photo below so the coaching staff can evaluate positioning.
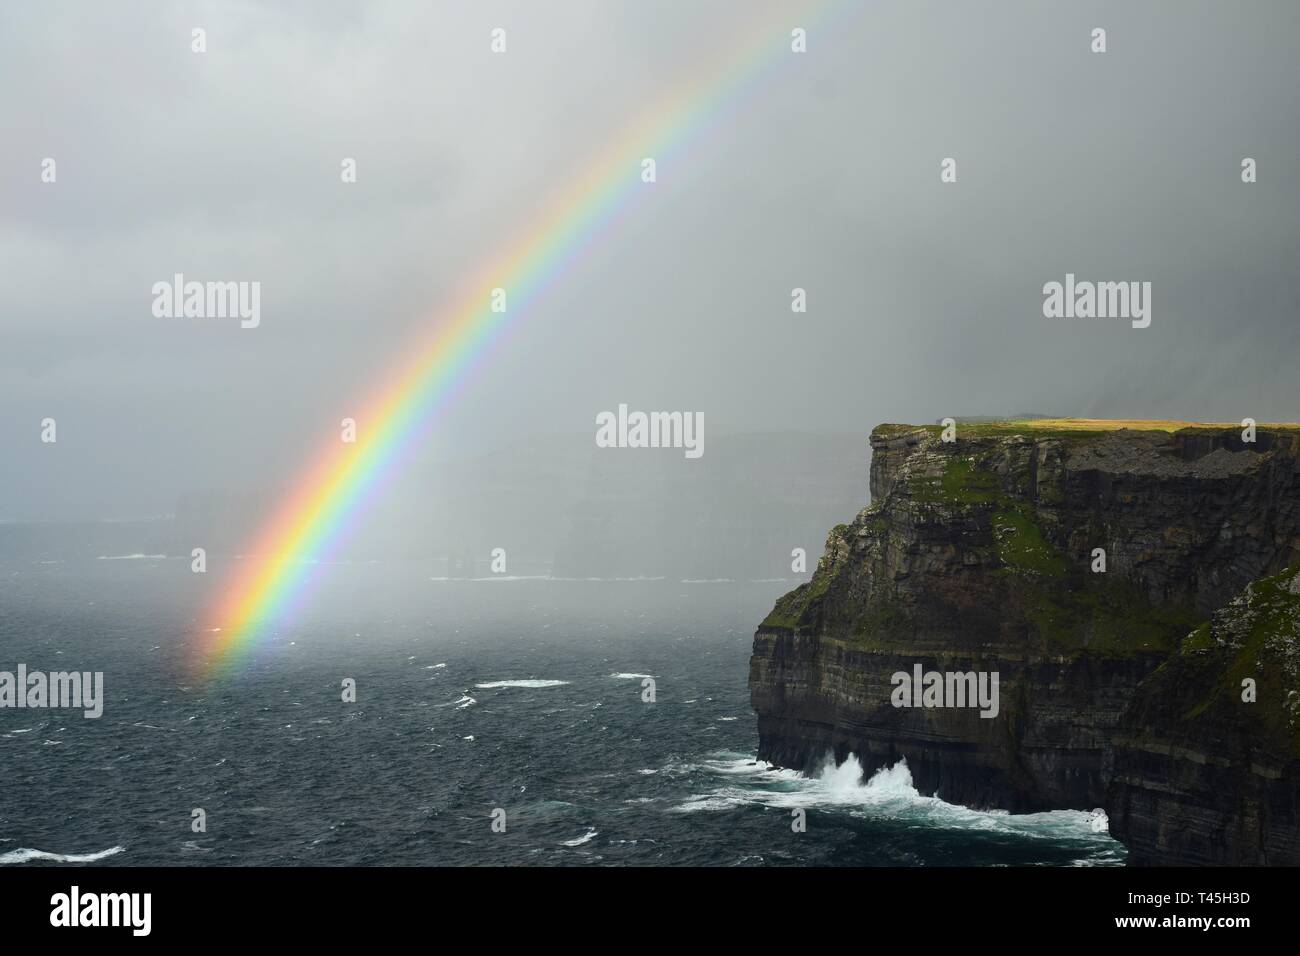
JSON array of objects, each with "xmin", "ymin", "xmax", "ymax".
[{"xmin": 0, "ymin": 554, "xmax": 1125, "ymax": 866}]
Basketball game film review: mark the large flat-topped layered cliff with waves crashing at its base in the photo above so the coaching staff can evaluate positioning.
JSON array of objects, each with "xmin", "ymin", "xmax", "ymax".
[{"xmin": 750, "ymin": 423, "xmax": 1300, "ymax": 862}]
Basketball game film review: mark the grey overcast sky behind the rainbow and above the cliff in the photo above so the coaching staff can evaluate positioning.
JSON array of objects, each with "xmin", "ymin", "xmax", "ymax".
[{"xmin": 0, "ymin": 0, "xmax": 1300, "ymax": 519}]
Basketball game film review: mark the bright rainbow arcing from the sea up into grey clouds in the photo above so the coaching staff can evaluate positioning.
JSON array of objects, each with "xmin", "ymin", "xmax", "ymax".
[{"xmin": 194, "ymin": 0, "xmax": 845, "ymax": 676}]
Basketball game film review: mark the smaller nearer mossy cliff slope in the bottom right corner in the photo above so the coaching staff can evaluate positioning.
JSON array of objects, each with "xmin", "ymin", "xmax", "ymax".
[{"xmin": 1106, "ymin": 568, "xmax": 1300, "ymax": 866}]
